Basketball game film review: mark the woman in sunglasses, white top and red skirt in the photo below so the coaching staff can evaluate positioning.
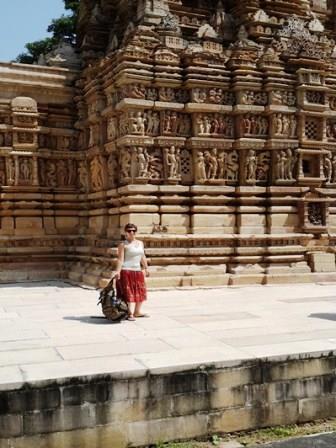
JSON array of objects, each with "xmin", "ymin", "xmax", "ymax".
[{"xmin": 116, "ymin": 224, "xmax": 149, "ymax": 320}]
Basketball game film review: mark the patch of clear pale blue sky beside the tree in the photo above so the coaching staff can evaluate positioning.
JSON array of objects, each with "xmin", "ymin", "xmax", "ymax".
[{"xmin": 0, "ymin": 0, "xmax": 66, "ymax": 62}]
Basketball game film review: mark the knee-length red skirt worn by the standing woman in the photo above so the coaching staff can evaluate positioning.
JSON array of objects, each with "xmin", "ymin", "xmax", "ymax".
[{"xmin": 116, "ymin": 270, "xmax": 147, "ymax": 302}]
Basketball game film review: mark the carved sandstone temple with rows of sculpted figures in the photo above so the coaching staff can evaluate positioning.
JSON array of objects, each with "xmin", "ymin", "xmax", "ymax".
[{"xmin": 0, "ymin": 0, "xmax": 336, "ymax": 286}]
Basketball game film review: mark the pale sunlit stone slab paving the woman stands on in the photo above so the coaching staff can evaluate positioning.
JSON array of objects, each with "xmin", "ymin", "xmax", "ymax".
[{"xmin": 0, "ymin": 282, "xmax": 336, "ymax": 388}]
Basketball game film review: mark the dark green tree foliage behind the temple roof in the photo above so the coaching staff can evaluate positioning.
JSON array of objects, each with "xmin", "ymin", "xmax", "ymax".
[{"xmin": 15, "ymin": 0, "xmax": 80, "ymax": 64}]
